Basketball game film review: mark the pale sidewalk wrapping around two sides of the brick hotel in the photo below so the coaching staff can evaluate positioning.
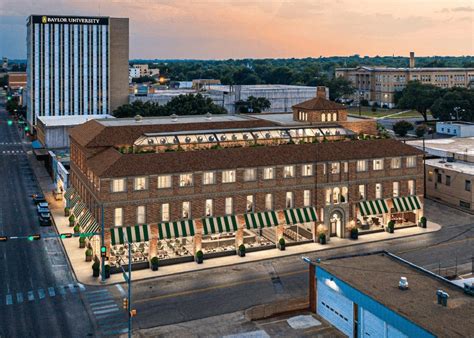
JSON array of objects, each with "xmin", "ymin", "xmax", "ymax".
[{"xmin": 31, "ymin": 151, "xmax": 441, "ymax": 285}]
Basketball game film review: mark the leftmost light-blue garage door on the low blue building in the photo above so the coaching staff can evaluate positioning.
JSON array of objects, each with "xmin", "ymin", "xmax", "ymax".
[{"xmin": 317, "ymin": 280, "xmax": 354, "ymax": 337}]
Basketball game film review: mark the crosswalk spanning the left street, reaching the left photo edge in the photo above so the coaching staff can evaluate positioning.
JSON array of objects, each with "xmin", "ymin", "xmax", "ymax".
[{"xmin": 0, "ymin": 283, "xmax": 86, "ymax": 306}]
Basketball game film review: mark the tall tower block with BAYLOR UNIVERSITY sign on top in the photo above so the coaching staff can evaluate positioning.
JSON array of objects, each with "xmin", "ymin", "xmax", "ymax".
[{"xmin": 27, "ymin": 15, "xmax": 129, "ymax": 125}]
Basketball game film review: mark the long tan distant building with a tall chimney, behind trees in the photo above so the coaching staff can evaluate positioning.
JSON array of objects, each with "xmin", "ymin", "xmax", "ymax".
[{"xmin": 336, "ymin": 52, "xmax": 474, "ymax": 108}]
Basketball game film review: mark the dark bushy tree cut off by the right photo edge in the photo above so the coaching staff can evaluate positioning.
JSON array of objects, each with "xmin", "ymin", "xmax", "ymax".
[{"xmin": 430, "ymin": 87, "xmax": 474, "ymax": 122}]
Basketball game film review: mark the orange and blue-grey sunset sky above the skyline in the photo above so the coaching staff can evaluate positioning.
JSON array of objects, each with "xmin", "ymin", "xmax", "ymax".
[{"xmin": 0, "ymin": 0, "xmax": 474, "ymax": 59}]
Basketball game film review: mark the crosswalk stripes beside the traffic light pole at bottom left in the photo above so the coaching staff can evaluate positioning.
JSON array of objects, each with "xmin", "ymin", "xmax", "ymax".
[{"xmin": 85, "ymin": 289, "xmax": 128, "ymax": 336}]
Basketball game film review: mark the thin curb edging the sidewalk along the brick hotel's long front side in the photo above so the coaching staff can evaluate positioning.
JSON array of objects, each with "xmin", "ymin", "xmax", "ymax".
[{"xmin": 76, "ymin": 226, "xmax": 442, "ymax": 286}]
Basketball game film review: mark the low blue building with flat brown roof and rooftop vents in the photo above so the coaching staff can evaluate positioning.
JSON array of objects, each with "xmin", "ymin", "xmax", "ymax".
[{"xmin": 309, "ymin": 251, "xmax": 474, "ymax": 338}]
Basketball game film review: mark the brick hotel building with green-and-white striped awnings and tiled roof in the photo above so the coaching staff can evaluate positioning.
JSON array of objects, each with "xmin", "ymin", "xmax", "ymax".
[{"xmin": 66, "ymin": 90, "xmax": 423, "ymax": 266}]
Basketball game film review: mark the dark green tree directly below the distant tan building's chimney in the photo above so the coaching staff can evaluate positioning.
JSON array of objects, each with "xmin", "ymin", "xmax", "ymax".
[{"xmin": 398, "ymin": 81, "xmax": 442, "ymax": 122}]
